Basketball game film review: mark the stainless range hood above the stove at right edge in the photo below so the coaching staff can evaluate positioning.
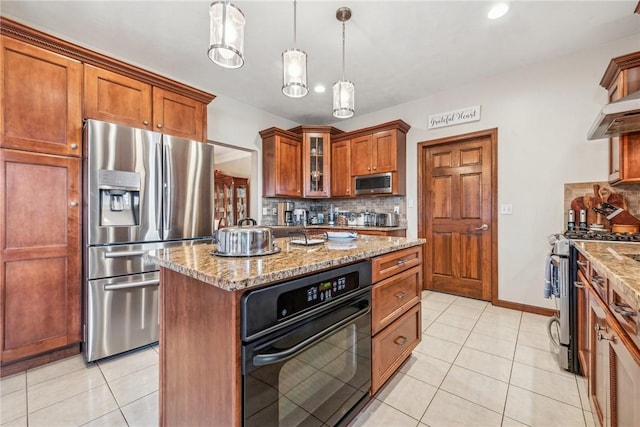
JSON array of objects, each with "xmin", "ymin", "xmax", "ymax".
[{"xmin": 587, "ymin": 91, "xmax": 640, "ymax": 140}]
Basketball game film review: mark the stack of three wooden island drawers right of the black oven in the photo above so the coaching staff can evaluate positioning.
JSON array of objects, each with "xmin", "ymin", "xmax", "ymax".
[{"xmin": 371, "ymin": 246, "xmax": 422, "ymax": 395}]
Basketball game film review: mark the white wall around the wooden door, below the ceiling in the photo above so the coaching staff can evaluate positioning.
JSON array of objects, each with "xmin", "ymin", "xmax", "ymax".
[{"xmin": 324, "ymin": 37, "xmax": 638, "ymax": 307}]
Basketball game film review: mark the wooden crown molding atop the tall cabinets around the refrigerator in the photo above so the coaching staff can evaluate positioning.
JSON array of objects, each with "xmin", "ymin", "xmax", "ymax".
[{"xmin": 0, "ymin": 16, "xmax": 215, "ymax": 104}]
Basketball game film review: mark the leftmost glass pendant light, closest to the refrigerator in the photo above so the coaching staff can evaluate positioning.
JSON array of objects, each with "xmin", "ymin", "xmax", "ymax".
[{"xmin": 208, "ymin": 0, "xmax": 245, "ymax": 68}]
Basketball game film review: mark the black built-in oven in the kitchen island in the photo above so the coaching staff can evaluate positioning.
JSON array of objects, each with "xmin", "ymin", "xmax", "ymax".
[{"xmin": 241, "ymin": 261, "xmax": 371, "ymax": 426}]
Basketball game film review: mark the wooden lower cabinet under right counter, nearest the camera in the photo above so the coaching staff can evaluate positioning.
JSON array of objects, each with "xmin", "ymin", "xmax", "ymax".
[{"xmin": 588, "ymin": 284, "xmax": 640, "ymax": 427}]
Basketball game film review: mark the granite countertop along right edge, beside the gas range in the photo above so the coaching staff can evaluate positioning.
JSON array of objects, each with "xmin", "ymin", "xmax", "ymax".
[{"xmin": 574, "ymin": 240, "xmax": 640, "ymax": 308}]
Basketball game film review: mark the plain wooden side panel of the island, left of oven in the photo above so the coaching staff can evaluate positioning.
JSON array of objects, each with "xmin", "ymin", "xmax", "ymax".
[{"xmin": 160, "ymin": 268, "xmax": 242, "ymax": 427}]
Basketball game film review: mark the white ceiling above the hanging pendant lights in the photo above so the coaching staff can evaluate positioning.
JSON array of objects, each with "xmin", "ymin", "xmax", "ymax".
[{"xmin": 2, "ymin": 0, "xmax": 640, "ymax": 125}]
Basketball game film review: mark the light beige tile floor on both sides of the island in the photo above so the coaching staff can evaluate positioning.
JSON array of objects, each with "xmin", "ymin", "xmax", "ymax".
[{"xmin": 0, "ymin": 291, "xmax": 595, "ymax": 427}]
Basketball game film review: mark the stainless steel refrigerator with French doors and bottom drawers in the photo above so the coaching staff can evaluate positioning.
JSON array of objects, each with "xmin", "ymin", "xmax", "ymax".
[{"xmin": 83, "ymin": 120, "xmax": 214, "ymax": 362}]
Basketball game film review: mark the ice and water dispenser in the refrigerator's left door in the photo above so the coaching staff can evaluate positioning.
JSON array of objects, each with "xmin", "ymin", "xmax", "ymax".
[{"xmin": 98, "ymin": 169, "xmax": 141, "ymax": 226}]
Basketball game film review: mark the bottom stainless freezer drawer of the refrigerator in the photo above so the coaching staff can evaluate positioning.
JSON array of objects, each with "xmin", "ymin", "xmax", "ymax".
[{"xmin": 85, "ymin": 272, "xmax": 160, "ymax": 362}]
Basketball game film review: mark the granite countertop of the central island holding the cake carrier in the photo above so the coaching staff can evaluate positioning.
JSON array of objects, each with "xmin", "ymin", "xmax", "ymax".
[{"xmin": 147, "ymin": 235, "xmax": 426, "ymax": 291}]
